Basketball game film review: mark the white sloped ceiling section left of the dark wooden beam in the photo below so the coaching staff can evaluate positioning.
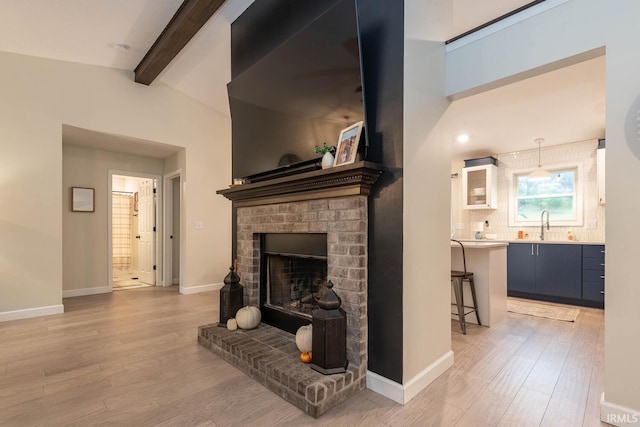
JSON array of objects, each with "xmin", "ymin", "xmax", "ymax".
[{"xmin": 0, "ymin": 0, "xmax": 182, "ymax": 70}]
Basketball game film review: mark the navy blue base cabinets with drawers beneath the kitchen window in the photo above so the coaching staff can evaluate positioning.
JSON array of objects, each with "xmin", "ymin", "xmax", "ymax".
[{"xmin": 507, "ymin": 243, "xmax": 604, "ymax": 307}]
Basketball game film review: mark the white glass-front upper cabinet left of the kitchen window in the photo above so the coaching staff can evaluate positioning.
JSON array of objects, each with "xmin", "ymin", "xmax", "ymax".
[{"xmin": 462, "ymin": 164, "xmax": 498, "ymax": 209}]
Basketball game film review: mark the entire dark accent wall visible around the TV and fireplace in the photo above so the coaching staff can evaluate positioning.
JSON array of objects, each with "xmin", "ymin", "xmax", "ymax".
[{"xmin": 231, "ymin": 0, "xmax": 404, "ymax": 383}]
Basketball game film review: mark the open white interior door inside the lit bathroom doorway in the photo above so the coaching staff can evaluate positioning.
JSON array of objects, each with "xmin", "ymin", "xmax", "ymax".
[{"xmin": 138, "ymin": 179, "xmax": 156, "ymax": 285}]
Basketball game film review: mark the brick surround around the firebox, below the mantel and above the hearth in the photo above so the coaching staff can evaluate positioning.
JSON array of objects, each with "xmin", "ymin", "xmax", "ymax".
[{"xmin": 237, "ymin": 196, "xmax": 367, "ymax": 366}]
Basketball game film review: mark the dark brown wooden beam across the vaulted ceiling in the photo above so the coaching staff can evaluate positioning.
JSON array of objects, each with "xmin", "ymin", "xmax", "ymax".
[{"xmin": 134, "ymin": 0, "xmax": 225, "ymax": 85}]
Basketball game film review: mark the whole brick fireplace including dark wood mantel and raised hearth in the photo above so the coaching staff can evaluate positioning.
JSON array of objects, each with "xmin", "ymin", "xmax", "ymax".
[{"xmin": 199, "ymin": 162, "xmax": 381, "ymax": 416}]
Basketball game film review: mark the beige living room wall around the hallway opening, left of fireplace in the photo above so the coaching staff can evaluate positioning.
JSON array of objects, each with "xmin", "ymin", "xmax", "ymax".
[{"xmin": 0, "ymin": 49, "xmax": 231, "ymax": 313}]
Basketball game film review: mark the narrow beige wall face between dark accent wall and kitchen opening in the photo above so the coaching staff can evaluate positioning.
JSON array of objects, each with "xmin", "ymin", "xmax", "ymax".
[{"xmin": 402, "ymin": 0, "xmax": 453, "ymax": 403}]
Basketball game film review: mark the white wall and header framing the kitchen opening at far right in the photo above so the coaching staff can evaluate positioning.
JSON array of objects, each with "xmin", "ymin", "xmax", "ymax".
[{"xmin": 447, "ymin": 0, "xmax": 640, "ymax": 422}]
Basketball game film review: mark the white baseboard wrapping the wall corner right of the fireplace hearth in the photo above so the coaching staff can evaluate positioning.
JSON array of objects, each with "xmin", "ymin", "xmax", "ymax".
[{"xmin": 367, "ymin": 351, "xmax": 453, "ymax": 405}]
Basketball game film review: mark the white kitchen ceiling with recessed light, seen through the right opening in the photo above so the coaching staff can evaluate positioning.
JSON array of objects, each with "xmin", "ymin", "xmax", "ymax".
[{"xmin": 447, "ymin": 56, "xmax": 605, "ymax": 160}]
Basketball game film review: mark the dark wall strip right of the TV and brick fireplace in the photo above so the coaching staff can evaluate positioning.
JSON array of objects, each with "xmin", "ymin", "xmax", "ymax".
[{"xmin": 358, "ymin": 0, "xmax": 404, "ymax": 384}]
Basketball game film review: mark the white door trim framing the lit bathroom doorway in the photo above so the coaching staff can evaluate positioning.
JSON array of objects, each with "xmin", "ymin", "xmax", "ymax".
[{"xmin": 105, "ymin": 169, "xmax": 164, "ymax": 291}]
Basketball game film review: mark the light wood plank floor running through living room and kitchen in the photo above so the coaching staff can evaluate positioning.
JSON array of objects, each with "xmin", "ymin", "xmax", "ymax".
[{"xmin": 0, "ymin": 287, "xmax": 604, "ymax": 427}]
